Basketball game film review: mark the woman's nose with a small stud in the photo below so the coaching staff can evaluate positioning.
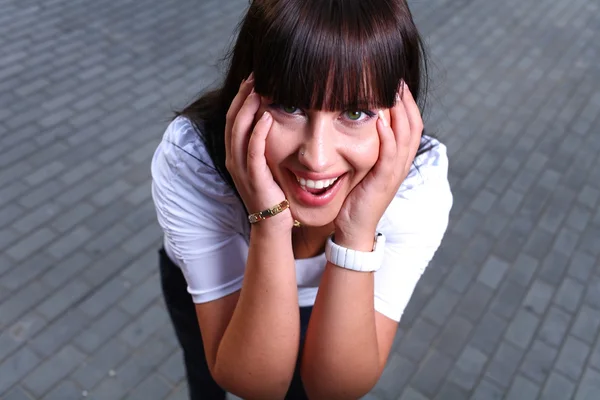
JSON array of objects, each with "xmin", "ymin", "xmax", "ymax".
[{"xmin": 299, "ymin": 118, "xmax": 336, "ymax": 172}]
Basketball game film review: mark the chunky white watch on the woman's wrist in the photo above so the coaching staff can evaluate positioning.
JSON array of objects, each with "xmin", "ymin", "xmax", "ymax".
[{"xmin": 325, "ymin": 233, "xmax": 385, "ymax": 272}]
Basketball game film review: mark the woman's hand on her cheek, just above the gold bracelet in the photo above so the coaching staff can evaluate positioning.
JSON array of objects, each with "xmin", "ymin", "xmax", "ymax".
[{"xmin": 225, "ymin": 74, "xmax": 294, "ymax": 230}]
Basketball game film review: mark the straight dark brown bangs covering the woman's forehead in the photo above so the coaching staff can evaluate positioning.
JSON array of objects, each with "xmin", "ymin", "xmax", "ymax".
[{"xmin": 252, "ymin": 0, "xmax": 407, "ymax": 111}]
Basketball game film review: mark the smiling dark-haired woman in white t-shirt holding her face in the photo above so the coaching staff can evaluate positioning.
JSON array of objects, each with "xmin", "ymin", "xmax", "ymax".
[{"xmin": 152, "ymin": 0, "xmax": 452, "ymax": 399}]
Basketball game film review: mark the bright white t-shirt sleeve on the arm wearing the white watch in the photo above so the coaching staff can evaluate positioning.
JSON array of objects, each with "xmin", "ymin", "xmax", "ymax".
[{"xmin": 374, "ymin": 141, "xmax": 452, "ymax": 321}]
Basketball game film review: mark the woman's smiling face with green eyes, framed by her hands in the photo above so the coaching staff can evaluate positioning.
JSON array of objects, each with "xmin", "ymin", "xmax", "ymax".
[{"xmin": 256, "ymin": 98, "xmax": 389, "ymax": 226}]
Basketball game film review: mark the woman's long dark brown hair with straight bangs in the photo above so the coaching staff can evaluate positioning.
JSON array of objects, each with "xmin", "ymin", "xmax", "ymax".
[{"xmin": 177, "ymin": 0, "xmax": 429, "ymax": 190}]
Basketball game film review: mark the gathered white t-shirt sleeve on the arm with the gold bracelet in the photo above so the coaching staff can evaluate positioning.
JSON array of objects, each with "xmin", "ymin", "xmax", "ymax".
[{"xmin": 151, "ymin": 118, "xmax": 248, "ymax": 303}]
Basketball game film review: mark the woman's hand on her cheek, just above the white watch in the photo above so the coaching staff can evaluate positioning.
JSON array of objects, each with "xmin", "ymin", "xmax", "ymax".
[{"xmin": 334, "ymin": 83, "xmax": 423, "ymax": 251}]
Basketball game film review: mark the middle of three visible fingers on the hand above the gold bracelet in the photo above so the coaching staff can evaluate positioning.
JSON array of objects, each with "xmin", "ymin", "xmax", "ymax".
[{"xmin": 230, "ymin": 92, "xmax": 260, "ymax": 168}]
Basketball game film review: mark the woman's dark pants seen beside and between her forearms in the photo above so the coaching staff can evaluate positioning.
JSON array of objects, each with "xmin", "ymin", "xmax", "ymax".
[{"xmin": 159, "ymin": 249, "xmax": 312, "ymax": 400}]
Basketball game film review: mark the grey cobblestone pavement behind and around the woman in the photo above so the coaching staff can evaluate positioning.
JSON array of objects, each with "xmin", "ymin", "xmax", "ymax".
[{"xmin": 0, "ymin": 0, "xmax": 600, "ymax": 400}]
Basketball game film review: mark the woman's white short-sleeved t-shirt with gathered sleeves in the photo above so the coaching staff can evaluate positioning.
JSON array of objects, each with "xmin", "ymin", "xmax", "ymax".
[{"xmin": 152, "ymin": 117, "xmax": 452, "ymax": 321}]
